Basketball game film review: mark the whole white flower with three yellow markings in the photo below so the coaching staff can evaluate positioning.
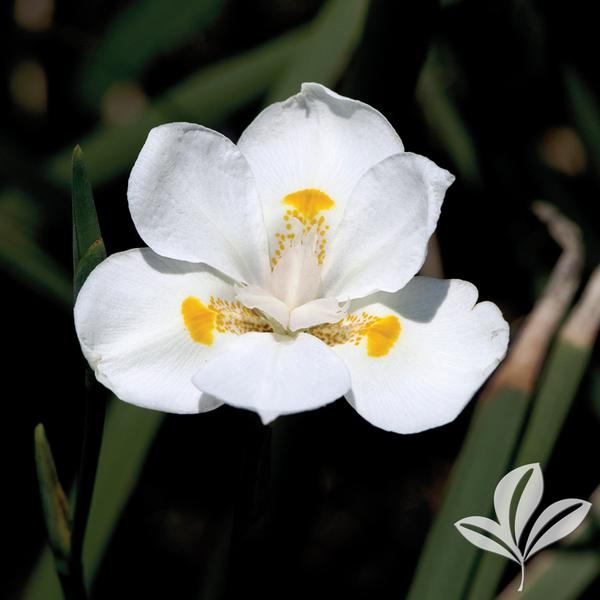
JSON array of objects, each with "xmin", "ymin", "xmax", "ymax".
[{"xmin": 75, "ymin": 83, "xmax": 508, "ymax": 433}]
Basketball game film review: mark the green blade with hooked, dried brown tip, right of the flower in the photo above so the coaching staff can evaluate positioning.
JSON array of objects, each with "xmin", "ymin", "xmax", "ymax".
[{"xmin": 408, "ymin": 203, "xmax": 581, "ymax": 600}]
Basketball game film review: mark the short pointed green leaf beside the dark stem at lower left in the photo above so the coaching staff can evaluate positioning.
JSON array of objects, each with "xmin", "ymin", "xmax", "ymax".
[{"xmin": 34, "ymin": 423, "xmax": 72, "ymax": 571}]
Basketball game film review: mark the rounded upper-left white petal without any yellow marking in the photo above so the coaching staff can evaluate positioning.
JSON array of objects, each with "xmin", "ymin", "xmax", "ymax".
[{"xmin": 128, "ymin": 123, "xmax": 269, "ymax": 285}]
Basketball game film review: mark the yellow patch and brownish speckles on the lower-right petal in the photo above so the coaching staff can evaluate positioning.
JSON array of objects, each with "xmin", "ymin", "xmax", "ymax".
[{"xmin": 307, "ymin": 312, "xmax": 402, "ymax": 358}]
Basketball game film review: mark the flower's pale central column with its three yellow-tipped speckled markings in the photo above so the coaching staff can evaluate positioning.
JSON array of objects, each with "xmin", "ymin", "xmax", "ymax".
[{"xmin": 181, "ymin": 188, "xmax": 401, "ymax": 357}]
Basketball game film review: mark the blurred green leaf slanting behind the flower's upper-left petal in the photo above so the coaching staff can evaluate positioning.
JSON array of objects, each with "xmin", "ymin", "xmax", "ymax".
[{"xmin": 44, "ymin": 27, "xmax": 306, "ymax": 187}]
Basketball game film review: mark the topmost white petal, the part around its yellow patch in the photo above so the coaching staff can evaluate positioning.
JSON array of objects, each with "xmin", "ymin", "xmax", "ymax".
[{"xmin": 238, "ymin": 83, "xmax": 404, "ymax": 241}]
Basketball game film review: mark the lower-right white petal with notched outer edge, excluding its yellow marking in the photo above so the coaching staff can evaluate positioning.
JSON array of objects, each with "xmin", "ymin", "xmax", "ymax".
[{"xmin": 333, "ymin": 277, "xmax": 508, "ymax": 433}]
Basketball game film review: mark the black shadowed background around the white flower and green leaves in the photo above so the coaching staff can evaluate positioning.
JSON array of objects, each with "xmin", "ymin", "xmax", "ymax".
[{"xmin": 0, "ymin": 0, "xmax": 600, "ymax": 599}]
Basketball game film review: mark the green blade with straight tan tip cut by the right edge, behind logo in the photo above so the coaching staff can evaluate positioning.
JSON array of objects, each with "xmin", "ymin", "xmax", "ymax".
[{"xmin": 468, "ymin": 268, "xmax": 600, "ymax": 600}]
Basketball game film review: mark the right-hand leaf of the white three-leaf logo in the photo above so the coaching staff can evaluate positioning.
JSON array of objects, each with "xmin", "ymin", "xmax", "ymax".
[{"xmin": 524, "ymin": 498, "xmax": 591, "ymax": 560}]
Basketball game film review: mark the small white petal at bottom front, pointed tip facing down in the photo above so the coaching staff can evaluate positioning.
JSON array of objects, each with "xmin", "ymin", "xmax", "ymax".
[{"xmin": 194, "ymin": 333, "xmax": 350, "ymax": 420}]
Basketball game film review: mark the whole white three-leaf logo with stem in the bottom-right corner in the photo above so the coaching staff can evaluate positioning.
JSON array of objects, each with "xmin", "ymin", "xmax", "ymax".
[{"xmin": 454, "ymin": 463, "xmax": 591, "ymax": 592}]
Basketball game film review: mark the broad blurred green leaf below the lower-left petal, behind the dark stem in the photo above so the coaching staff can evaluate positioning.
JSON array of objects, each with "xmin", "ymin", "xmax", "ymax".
[{"xmin": 23, "ymin": 399, "xmax": 164, "ymax": 600}]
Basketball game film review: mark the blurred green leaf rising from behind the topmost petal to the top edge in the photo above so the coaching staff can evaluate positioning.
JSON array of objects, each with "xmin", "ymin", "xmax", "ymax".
[{"xmin": 265, "ymin": 0, "xmax": 369, "ymax": 104}]
